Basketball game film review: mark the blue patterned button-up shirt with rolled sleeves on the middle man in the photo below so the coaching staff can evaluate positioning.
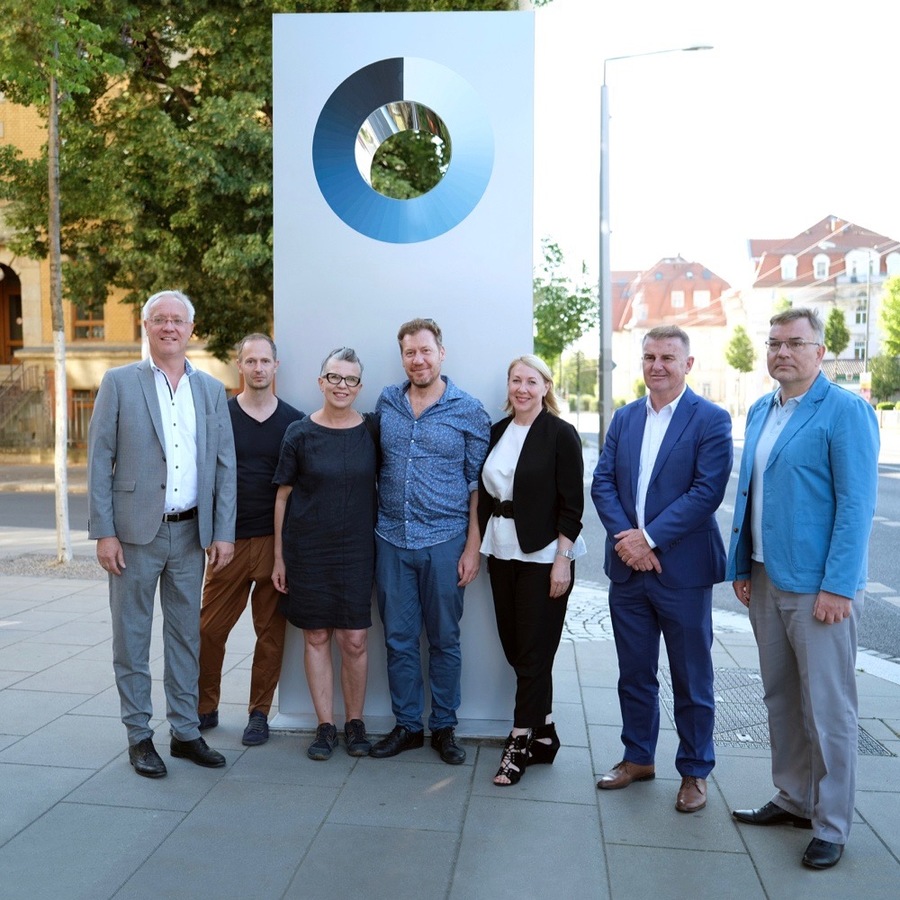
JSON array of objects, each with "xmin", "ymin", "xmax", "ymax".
[{"xmin": 375, "ymin": 375, "xmax": 491, "ymax": 550}]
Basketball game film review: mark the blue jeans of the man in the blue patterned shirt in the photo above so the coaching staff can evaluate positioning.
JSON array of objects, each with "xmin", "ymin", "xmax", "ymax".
[{"xmin": 375, "ymin": 532, "xmax": 466, "ymax": 731}]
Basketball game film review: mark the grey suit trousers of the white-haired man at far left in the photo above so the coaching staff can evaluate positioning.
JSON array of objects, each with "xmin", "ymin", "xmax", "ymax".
[{"xmin": 109, "ymin": 519, "xmax": 205, "ymax": 744}]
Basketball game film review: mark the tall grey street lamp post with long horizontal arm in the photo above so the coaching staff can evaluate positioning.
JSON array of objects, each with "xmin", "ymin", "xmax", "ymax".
[{"xmin": 597, "ymin": 44, "xmax": 712, "ymax": 450}]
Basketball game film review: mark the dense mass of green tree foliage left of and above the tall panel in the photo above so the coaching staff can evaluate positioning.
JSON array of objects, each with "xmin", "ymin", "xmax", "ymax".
[{"xmin": 0, "ymin": 0, "xmax": 516, "ymax": 359}]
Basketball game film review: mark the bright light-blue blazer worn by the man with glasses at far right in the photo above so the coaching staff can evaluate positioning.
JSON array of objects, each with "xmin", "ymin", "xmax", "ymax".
[{"xmin": 727, "ymin": 373, "xmax": 879, "ymax": 598}]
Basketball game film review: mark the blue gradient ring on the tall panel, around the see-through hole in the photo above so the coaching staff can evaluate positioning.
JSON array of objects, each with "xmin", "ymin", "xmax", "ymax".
[{"xmin": 312, "ymin": 57, "xmax": 494, "ymax": 244}]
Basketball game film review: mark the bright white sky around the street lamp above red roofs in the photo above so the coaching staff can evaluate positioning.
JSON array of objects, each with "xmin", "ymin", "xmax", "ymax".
[{"xmin": 534, "ymin": 0, "xmax": 900, "ymax": 287}]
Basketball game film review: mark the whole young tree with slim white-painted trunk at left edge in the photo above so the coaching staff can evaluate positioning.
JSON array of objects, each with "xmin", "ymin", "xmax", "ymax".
[{"xmin": 0, "ymin": 0, "xmax": 119, "ymax": 563}]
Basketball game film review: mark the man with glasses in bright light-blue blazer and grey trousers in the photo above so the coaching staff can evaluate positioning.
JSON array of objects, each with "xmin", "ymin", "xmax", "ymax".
[{"xmin": 727, "ymin": 307, "xmax": 879, "ymax": 869}]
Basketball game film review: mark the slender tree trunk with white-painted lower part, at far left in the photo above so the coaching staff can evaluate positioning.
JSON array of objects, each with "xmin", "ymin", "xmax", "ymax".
[{"xmin": 47, "ymin": 67, "xmax": 72, "ymax": 563}]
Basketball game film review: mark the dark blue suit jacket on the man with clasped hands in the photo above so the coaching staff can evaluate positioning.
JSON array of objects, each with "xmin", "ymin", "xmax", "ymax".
[{"xmin": 591, "ymin": 388, "xmax": 733, "ymax": 588}]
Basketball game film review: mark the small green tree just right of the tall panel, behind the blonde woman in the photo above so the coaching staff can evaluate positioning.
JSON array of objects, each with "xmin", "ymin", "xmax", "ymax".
[{"xmin": 534, "ymin": 238, "xmax": 597, "ymax": 366}]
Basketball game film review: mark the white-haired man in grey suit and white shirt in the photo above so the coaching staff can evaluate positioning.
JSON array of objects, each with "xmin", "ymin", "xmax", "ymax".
[{"xmin": 88, "ymin": 291, "xmax": 236, "ymax": 778}]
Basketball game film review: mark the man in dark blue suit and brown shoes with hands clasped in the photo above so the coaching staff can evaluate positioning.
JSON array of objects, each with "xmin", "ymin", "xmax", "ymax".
[{"xmin": 591, "ymin": 326, "xmax": 732, "ymax": 813}]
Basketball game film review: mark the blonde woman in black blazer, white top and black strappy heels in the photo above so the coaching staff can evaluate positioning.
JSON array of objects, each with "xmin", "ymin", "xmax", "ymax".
[{"xmin": 478, "ymin": 354, "xmax": 584, "ymax": 785}]
